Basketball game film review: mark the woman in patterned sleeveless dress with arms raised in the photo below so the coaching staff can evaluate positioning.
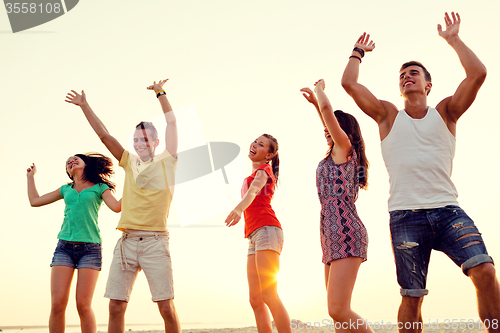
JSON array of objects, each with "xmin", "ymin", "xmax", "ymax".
[{"xmin": 301, "ymin": 80, "xmax": 372, "ymax": 332}]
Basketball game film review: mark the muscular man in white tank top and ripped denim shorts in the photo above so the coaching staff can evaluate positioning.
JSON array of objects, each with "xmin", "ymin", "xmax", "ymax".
[{"xmin": 342, "ymin": 13, "xmax": 500, "ymax": 332}]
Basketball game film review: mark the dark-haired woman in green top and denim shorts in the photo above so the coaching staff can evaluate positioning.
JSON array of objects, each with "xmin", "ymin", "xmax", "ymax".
[{"xmin": 27, "ymin": 153, "xmax": 121, "ymax": 333}]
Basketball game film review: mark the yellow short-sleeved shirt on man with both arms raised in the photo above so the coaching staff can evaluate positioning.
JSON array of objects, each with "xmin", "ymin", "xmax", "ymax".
[{"xmin": 116, "ymin": 150, "xmax": 177, "ymax": 231}]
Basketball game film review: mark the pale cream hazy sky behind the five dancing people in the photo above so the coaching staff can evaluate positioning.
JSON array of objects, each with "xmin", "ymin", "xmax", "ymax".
[{"xmin": 0, "ymin": 0, "xmax": 500, "ymax": 325}]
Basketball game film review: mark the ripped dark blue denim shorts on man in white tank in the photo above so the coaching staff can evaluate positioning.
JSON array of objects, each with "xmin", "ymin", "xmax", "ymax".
[{"xmin": 390, "ymin": 206, "xmax": 493, "ymax": 297}]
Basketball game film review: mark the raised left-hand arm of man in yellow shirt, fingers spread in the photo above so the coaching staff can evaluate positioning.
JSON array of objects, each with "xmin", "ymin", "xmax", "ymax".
[{"xmin": 65, "ymin": 90, "xmax": 125, "ymax": 161}]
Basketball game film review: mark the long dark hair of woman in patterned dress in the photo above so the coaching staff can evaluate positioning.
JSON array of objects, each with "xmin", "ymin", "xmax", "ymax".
[{"xmin": 325, "ymin": 110, "xmax": 370, "ymax": 190}]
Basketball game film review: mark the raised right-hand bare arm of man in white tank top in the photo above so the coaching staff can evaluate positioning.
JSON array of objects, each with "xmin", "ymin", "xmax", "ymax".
[{"xmin": 436, "ymin": 12, "xmax": 486, "ymax": 123}]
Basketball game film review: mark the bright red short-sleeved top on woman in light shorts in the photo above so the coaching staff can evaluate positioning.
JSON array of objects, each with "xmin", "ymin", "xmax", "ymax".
[{"xmin": 241, "ymin": 163, "xmax": 281, "ymax": 238}]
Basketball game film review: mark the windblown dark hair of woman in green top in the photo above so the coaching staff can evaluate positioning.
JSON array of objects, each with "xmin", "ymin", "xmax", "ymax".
[{"xmin": 66, "ymin": 153, "xmax": 116, "ymax": 191}]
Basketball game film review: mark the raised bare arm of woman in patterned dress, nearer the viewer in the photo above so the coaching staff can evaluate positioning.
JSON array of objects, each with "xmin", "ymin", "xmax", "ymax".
[{"xmin": 314, "ymin": 80, "xmax": 351, "ymax": 152}]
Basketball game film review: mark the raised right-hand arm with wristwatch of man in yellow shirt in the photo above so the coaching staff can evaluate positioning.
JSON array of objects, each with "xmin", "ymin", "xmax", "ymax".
[{"xmin": 147, "ymin": 79, "xmax": 178, "ymax": 158}]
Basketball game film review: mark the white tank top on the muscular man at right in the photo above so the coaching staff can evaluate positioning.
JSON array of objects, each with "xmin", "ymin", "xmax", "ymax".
[{"xmin": 381, "ymin": 108, "xmax": 458, "ymax": 211}]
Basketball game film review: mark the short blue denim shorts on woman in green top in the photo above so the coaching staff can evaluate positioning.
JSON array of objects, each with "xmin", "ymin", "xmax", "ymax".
[{"xmin": 50, "ymin": 239, "xmax": 102, "ymax": 271}]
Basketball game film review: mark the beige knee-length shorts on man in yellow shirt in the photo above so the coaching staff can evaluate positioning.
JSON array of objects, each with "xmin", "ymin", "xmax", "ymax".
[{"xmin": 104, "ymin": 230, "xmax": 174, "ymax": 302}]
